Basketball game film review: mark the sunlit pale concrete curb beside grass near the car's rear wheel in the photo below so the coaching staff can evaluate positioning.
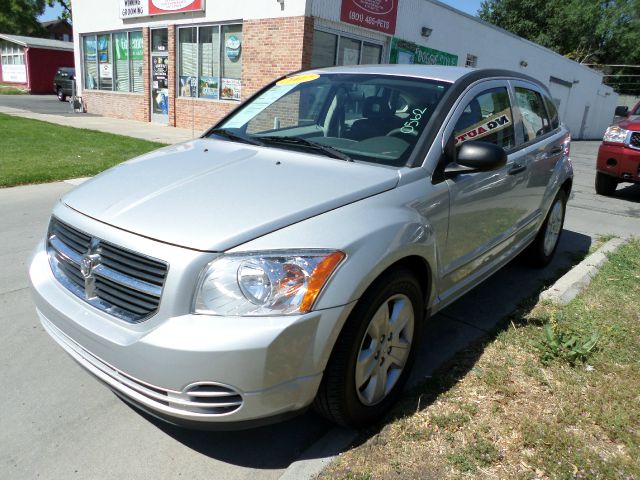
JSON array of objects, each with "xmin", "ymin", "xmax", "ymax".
[{"xmin": 540, "ymin": 238, "xmax": 627, "ymax": 305}]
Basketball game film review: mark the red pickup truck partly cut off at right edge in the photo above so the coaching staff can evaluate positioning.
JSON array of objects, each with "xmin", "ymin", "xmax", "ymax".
[{"xmin": 596, "ymin": 102, "xmax": 640, "ymax": 195}]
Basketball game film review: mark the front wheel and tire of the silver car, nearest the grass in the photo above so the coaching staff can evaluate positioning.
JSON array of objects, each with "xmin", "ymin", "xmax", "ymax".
[{"xmin": 314, "ymin": 269, "xmax": 424, "ymax": 428}]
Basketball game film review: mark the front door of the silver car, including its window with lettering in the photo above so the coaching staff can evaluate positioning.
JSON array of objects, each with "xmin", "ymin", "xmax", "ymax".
[{"xmin": 440, "ymin": 80, "xmax": 528, "ymax": 301}]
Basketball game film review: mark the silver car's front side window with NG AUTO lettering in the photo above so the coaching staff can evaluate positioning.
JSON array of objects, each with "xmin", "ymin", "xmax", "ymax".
[{"xmin": 454, "ymin": 87, "xmax": 515, "ymax": 150}]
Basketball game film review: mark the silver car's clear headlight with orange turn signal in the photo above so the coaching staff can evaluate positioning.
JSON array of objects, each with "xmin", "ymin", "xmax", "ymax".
[{"xmin": 193, "ymin": 250, "xmax": 345, "ymax": 316}]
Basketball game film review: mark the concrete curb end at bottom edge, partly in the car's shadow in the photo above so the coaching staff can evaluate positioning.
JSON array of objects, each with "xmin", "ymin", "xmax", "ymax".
[{"xmin": 278, "ymin": 427, "xmax": 358, "ymax": 480}]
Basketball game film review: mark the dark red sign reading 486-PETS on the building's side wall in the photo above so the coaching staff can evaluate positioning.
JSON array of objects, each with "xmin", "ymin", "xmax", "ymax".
[{"xmin": 340, "ymin": 0, "xmax": 398, "ymax": 35}]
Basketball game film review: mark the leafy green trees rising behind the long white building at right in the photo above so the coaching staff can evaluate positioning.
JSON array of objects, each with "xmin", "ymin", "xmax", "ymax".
[{"xmin": 478, "ymin": 0, "xmax": 640, "ymax": 93}]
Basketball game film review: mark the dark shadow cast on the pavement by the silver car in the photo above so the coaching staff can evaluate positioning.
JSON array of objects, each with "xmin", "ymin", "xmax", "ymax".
[{"xmin": 124, "ymin": 230, "xmax": 591, "ymax": 469}]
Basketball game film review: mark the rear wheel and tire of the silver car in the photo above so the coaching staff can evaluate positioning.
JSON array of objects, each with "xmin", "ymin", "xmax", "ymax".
[{"xmin": 523, "ymin": 190, "xmax": 567, "ymax": 268}]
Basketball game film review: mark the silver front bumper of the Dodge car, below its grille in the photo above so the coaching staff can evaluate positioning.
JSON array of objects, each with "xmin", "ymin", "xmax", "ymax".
[{"xmin": 29, "ymin": 240, "xmax": 352, "ymax": 428}]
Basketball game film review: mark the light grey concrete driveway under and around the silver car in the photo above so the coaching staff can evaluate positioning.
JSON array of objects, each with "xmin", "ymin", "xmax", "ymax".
[{"xmin": 0, "ymin": 142, "xmax": 640, "ymax": 480}]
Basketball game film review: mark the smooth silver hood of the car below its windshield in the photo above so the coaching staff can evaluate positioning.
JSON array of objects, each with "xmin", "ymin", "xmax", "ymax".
[{"xmin": 62, "ymin": 139, "xmax": 399, "ymax": 251}]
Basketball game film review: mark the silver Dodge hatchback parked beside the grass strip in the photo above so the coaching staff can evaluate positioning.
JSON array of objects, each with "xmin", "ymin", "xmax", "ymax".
[{"xmin": 30, "ymin": 65, "xmax": 573, "ymax": 428}]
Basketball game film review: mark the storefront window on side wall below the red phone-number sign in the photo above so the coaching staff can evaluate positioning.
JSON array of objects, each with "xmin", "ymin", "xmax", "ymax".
[{"xmin": 311, "ymin": 30, "xmax": 382, "ymax": 68}]
